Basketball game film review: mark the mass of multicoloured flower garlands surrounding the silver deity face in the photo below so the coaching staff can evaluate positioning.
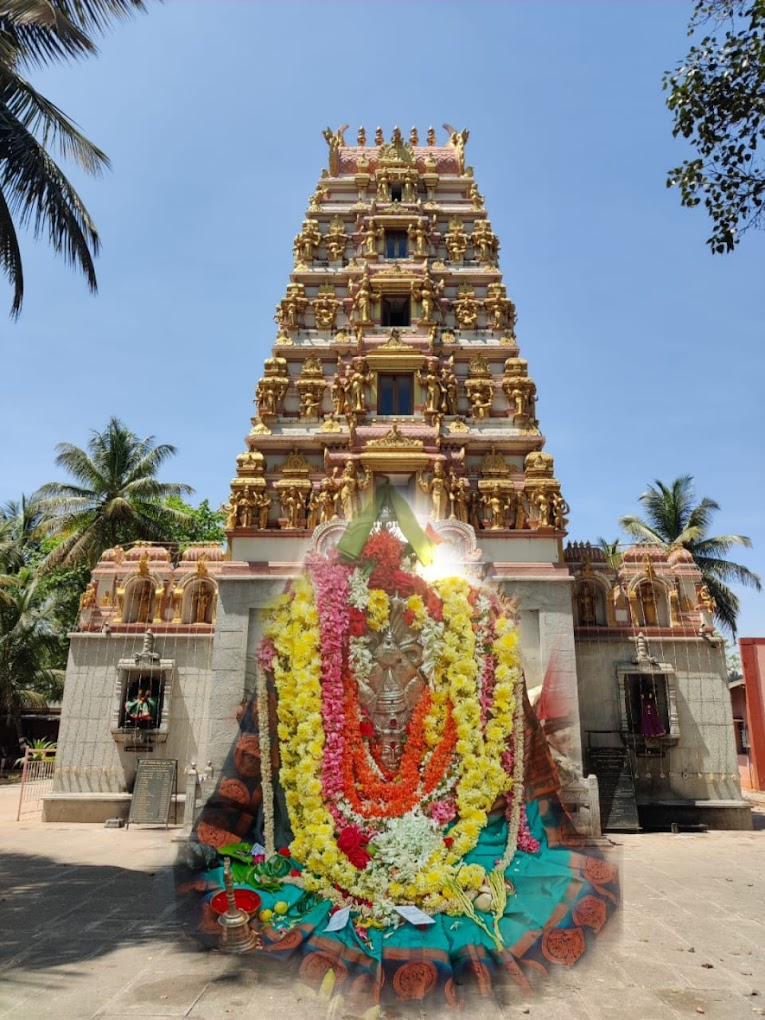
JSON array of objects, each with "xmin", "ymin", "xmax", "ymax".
[{"xmin": 258, "ymin": 526, "xmax": 522, "ymax": 923}]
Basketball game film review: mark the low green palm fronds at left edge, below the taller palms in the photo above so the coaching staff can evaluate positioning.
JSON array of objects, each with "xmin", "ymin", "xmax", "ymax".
[{"xmin": 0, "ymin": 567, "xmax": 63, "ymax": 736}]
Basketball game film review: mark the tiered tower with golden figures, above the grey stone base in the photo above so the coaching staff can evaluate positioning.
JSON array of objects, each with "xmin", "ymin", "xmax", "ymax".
[{"xmin": 226, "ymin": 128, "xmax": 570, "ymax": 644}]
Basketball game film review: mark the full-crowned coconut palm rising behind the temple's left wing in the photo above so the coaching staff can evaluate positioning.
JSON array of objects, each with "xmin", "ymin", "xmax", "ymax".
[{"xmin": 37, "ymin": 418, "xmax": 193, "ymax": 570}]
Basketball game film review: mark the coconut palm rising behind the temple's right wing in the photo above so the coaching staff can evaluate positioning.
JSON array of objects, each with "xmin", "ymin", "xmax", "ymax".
[{"xmin": 619, "ymin": 474, "xmax": 762, "ymax": 633}]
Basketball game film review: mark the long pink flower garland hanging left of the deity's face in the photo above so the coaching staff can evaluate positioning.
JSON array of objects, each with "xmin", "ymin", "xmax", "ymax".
[{"xmin": 310, "ymin": 558, "xmax": 350, "ymax": 828}]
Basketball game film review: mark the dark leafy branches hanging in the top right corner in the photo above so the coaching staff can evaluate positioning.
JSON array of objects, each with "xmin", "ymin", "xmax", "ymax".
[{"xmin": 664, "ymin": 0, "xmax": 765, "ymax": 254}]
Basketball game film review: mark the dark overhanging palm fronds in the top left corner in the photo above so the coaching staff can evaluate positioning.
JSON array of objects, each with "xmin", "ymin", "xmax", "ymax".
[{"xmin": 0, "ymin": 0, "xmax": 144, "ymax": 316}]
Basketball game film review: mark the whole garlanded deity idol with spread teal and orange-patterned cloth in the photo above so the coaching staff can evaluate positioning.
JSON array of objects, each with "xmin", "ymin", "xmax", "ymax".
[{"xmin": 180, "ymin": 497, "xmax": 618, "ymax": 1012}]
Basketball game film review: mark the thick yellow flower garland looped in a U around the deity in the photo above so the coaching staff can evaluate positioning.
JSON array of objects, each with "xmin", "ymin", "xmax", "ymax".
[{"xmin": 265, "ymin": 576, "xmax": 520, "ymax": 911}]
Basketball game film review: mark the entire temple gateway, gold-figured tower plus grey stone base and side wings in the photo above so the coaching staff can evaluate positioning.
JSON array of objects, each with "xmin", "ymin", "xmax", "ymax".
[{"xmin": 45, "ymin": 125, "xmax": 751, "ymax": 834}]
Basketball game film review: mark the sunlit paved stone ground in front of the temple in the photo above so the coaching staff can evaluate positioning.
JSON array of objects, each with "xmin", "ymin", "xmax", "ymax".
[{"xmin": 0, "ymin": 786, "xmax": 765, "ymax": 1020}]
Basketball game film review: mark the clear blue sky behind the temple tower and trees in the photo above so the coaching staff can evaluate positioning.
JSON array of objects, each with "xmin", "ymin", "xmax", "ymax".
[{"xmin": 0, "ymin": 0, "xmax": 765, "ymax": 635}]
